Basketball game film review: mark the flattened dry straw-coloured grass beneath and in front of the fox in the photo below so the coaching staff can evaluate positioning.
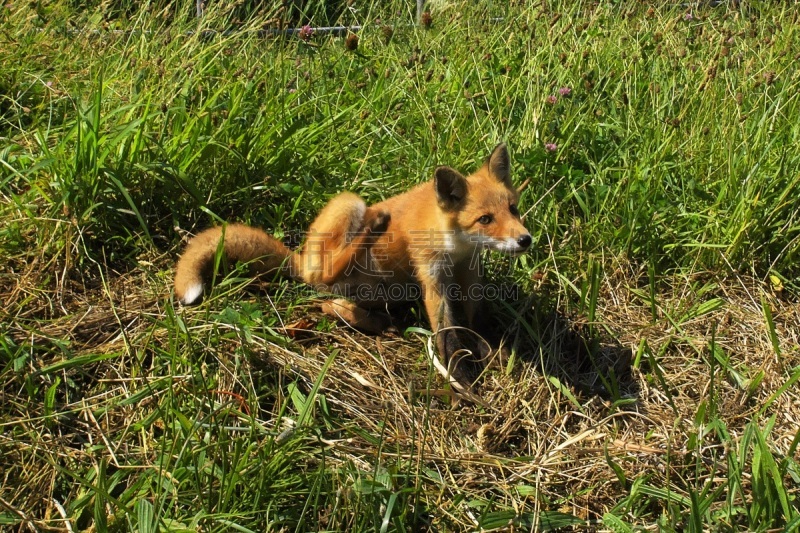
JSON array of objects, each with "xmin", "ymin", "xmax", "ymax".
[{"xmin": 0, "ymin": 251, "xmax": 800, "ymax": 529}]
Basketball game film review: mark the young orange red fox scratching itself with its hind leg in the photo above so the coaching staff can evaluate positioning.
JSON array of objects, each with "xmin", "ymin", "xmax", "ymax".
[{"xmin": 175, "ymin": 144, "xmax": 532, "ymax": 384}]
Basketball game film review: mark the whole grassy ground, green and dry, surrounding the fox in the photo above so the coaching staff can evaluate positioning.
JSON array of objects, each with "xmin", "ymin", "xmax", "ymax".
[{"xmin": 0, "ymin": 0, "xmax": 800, "ymax": 531}]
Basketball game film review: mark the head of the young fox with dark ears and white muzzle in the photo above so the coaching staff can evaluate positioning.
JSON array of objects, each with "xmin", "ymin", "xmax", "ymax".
[{"xmin": 433, "ymin": 144, "xmax": 533, "ymax": 255}]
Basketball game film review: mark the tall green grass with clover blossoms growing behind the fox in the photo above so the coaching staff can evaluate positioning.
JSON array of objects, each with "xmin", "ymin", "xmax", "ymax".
[{"xmin": 3, "ymin": 3, "xmax": 798, "ymax": 278}]
